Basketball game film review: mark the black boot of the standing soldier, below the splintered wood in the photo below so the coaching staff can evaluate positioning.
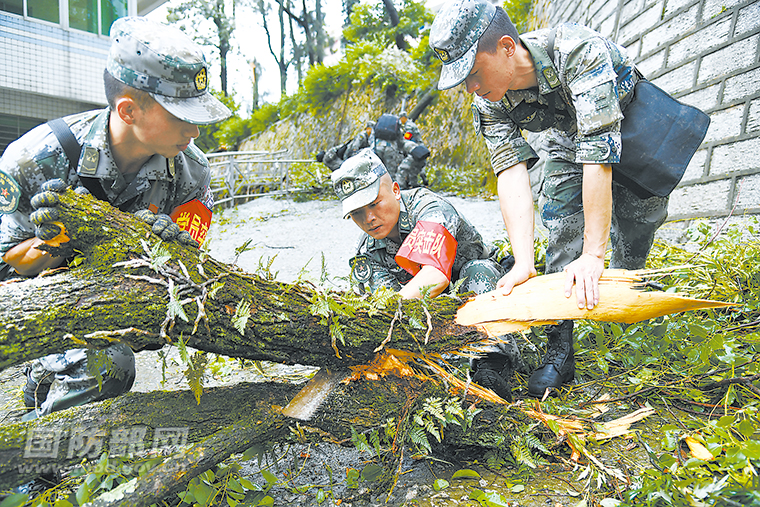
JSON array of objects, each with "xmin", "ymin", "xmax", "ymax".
[{"xmin": 528, "ymin": 320, "xmax": 575, "ymax": 398}]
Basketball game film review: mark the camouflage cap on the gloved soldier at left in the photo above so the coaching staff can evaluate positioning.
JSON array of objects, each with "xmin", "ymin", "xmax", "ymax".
[{"xmin": 106, "ymin": 16, "xmax": 232, "ymax": 125}]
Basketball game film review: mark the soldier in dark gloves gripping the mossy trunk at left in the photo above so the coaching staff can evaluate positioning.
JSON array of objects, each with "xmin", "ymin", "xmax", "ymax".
[{"xmin": 0, "ymin": 17, "xmax": 230, "ymax": 420}]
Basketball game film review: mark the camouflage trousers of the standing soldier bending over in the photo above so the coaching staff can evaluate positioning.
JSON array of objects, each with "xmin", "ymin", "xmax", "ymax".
[{"xmin": 539, "ymin": 160, "xmax": 668, "ymax": 274}]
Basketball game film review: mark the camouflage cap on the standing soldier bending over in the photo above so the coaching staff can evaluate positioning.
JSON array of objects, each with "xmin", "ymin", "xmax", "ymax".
[{"xmin": 429, "ymin": 0, "xmax": 496, "ymax": 90}]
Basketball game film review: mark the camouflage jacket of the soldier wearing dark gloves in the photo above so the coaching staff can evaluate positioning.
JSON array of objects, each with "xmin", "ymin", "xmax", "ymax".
[{"xmin": 0, "ymin": 109, "xmax": 214, "ymax": 256}]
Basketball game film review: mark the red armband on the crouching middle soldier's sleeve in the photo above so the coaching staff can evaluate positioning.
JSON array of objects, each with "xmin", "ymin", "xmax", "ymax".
[{"xmin": 395, "ymin": 221, "xmax": 457, "ymax": 281}]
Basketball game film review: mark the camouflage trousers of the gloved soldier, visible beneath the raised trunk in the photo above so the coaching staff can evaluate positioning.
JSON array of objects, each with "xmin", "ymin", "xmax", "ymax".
[{"xmin": 22, "ymin": 343, "xmax": 135, "ymax": 421}]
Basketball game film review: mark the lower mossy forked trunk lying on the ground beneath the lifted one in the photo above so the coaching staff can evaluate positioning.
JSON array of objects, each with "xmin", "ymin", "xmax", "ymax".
[{"xmin": 0, "ymin": 378, "xmax": 470, "ymax": 500}]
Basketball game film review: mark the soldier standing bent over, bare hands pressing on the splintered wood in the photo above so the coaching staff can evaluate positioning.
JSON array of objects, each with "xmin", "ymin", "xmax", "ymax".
[{"xmin": 430, "ymin": 0, "xmax": 668, "ymax": 396}]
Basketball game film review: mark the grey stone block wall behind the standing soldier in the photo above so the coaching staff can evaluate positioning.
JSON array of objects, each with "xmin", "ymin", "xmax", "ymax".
[{"xmin": 534, "ymin": 0, "xmax": 760, "ymax": 232}]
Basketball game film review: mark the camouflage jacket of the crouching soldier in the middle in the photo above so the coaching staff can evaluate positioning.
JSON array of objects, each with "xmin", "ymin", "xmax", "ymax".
[{"xmin": 349, "ymin": 188, "xmax": 495, "ymax": 292}]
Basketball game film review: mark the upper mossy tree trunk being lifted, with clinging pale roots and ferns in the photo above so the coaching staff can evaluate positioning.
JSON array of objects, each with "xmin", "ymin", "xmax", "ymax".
[{"xmin": 0, "ymin": 191, "xmax": 483, "ymax": 369}]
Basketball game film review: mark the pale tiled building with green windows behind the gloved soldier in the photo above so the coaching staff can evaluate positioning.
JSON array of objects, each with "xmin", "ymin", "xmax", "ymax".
[{"xmin": 0, "ymin": 0, "xmax": 165, "ymax": 154}]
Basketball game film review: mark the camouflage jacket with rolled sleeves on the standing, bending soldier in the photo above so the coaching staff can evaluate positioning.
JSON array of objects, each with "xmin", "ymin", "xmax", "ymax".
[{"xmin": 472, "ymin": 23, "xmax": 639, "ymax": 174}]
